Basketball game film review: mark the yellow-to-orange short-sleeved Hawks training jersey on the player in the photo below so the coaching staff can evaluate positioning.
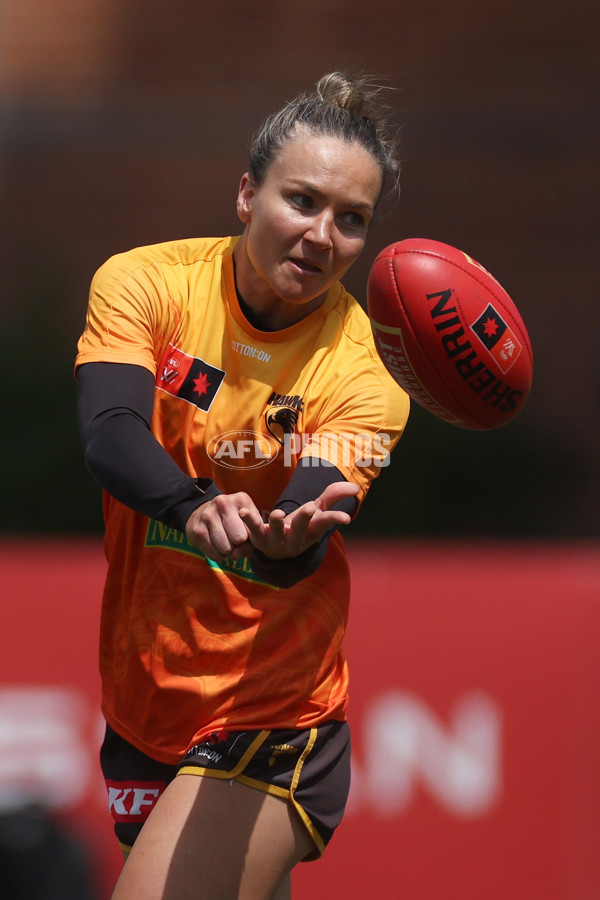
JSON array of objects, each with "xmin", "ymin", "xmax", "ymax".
[{"xmin": 77, "ymin": 238, "xmax": 408, "ymax": 763}]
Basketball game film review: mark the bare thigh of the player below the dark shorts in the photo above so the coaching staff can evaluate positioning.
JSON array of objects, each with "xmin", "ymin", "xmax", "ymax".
[{"xmin": 113, "ymin": 774, "xmax": 312, "ymax": 900}]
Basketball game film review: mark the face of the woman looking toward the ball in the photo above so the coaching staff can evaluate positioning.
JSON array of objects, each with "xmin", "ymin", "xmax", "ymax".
[{"xmin": 235, "ymin": 131, "xmax": 382, "ymax": 329}]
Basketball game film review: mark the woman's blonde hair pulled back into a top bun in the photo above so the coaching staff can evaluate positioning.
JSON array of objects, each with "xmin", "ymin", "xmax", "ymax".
[{"xmin": 248, "ymin": 72, "xmax": 400, "ymax": 206}]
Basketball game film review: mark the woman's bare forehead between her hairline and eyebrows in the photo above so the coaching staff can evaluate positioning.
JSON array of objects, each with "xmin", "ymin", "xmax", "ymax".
[{"xmin": 265, "ymin": 131, "xmax": 382, "ymax": 206}]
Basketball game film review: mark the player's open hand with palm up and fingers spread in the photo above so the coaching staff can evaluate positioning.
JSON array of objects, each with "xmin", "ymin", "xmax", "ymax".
[{"xmin": 236, "ymin": 481, "xmax": 358, "ymax": 559}]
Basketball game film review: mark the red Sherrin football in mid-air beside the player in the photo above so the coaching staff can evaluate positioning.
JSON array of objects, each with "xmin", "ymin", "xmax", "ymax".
[{"xmin": 367, "ymin": 238, "xmax": 533, "ymax": 429}]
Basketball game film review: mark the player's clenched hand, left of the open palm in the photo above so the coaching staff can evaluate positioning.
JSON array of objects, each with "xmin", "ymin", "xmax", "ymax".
[{"xmin": 185, "ymin": 491, "xmax": 260, "ymax": 562}]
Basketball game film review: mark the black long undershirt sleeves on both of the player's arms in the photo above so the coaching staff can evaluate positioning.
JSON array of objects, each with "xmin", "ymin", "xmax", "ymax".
[{"xmin": 77, "ymin": 363, "xmax": 356, "ymax": 587}]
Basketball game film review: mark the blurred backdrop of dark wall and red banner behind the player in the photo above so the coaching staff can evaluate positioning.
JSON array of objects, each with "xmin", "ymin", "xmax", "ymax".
[{"xmin": 0, "ymin": 0, "xmax": 600, "ymax": 900}]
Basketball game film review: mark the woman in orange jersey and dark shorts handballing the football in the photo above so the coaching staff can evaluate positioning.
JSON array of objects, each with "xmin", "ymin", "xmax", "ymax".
[{"xmin": 77, "ymin": 73, "xmax": 408, "ymax": 900}]
